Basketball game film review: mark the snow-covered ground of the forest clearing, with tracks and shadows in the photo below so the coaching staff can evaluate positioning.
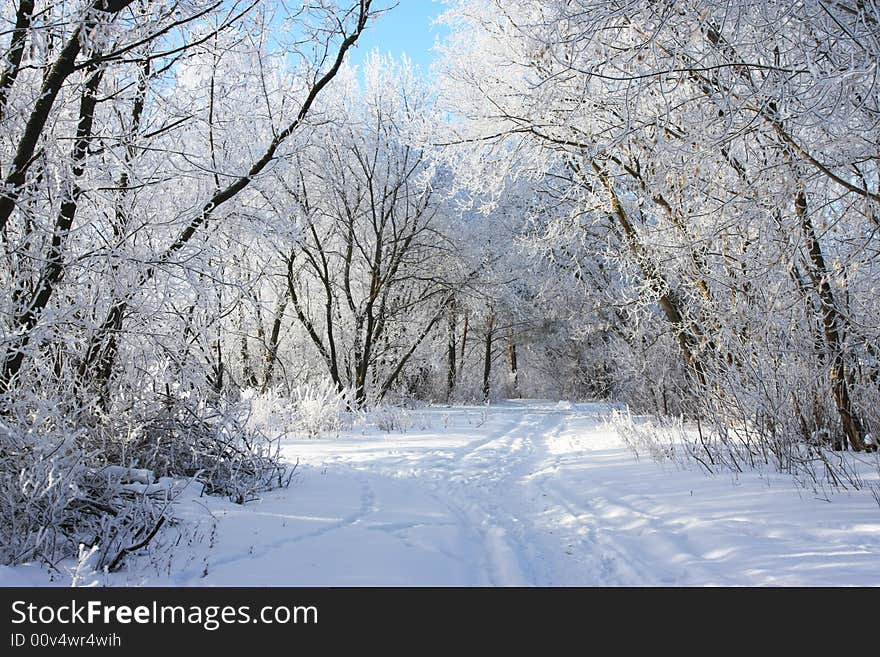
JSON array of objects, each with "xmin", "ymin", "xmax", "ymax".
[{"xmin": 0, "ymin": 401, "xmax": 880, "ymax": 586}]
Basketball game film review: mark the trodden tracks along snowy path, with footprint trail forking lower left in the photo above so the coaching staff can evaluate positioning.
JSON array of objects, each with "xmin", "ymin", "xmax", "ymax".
[{"xmin": 194, "ymin": 405, "xmax": 717, "ymax": 586}]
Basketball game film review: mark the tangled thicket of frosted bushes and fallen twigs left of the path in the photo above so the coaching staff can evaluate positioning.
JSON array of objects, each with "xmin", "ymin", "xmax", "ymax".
[{"xmin": 0, "ymin": 390, "xmax": 293, "ymax": 571}]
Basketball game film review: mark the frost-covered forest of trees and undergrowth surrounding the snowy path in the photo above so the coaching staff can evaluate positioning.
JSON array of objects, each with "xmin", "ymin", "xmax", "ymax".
[{"xmin": 0, "ymin": 0, "xmax": 880, "ymax": 571}]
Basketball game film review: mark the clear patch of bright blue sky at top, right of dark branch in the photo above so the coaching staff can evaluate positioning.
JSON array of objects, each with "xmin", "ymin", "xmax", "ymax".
[{"xmin": 350, "ymin": 0, "xmax": 446, "ymax": 73}]
